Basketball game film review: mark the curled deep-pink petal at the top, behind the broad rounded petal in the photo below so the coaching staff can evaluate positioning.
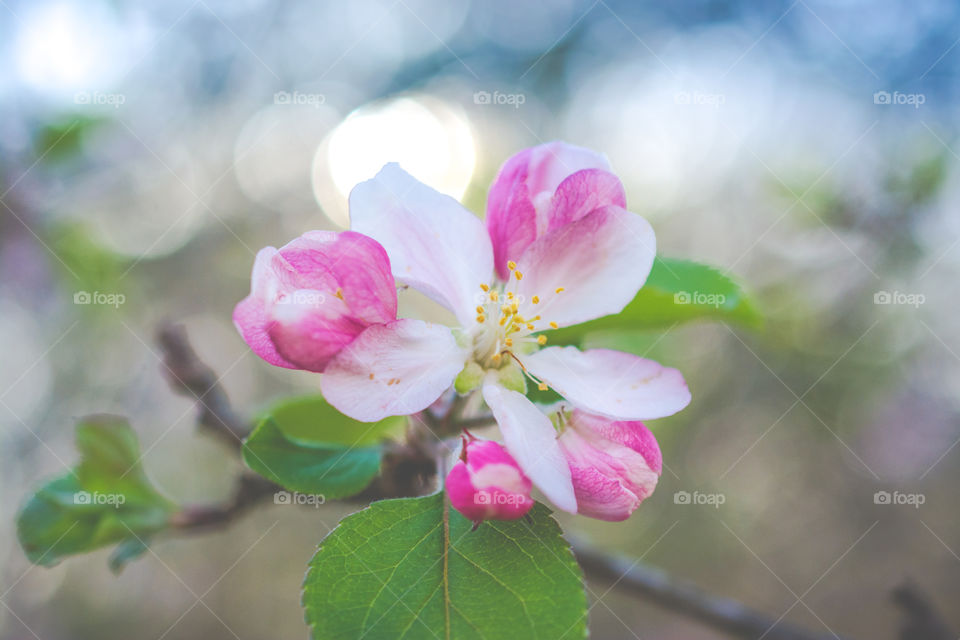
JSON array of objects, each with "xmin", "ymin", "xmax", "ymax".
[{"xmin": 487, "ymin": 142, "xmax": 610, "ymax": 280}]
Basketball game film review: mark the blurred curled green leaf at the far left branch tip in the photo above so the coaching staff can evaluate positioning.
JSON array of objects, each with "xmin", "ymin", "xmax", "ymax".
[{"xmin": 17, "ymin": 416, "xmax": 174, "ymax": 565}]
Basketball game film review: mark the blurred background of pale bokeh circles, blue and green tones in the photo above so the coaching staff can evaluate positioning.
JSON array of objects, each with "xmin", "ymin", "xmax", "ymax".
[{"xmin": 0, "ymin": 0, "xmax": 960, "ymax": 640}]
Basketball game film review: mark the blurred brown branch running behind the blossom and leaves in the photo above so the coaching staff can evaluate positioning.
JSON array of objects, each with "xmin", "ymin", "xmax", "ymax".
[{"xmin": 158, "ymin": 325, "xmax": 957, "ymax": 640}]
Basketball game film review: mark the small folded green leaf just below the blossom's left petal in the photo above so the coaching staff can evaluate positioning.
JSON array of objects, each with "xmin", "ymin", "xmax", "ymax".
[{"xmin": 243, "ymin": 396, "xmax": 406, "ymax": 499}]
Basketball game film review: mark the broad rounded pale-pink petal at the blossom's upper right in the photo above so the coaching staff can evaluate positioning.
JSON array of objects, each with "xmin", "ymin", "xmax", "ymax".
[{"xmin": 515, "ymin": 206, "xmax": 656, "ymax": 327}]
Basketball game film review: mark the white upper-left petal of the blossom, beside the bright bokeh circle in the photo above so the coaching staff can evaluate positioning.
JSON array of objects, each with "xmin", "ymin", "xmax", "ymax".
[{"xmin": 350, "ymin": 164, "xmax": 493, "ymax": 325}]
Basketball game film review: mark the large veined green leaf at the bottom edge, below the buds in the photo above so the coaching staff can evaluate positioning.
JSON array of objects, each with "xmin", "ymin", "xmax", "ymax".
[{"xmin": 303, "ymin": 494, "xmax": 587, "ymax": 640}]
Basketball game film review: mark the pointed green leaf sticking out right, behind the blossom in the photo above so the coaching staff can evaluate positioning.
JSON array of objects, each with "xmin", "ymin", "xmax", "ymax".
[{"xmin": 549, "ymin": 256, "xmax": 762, "ymax": 344}]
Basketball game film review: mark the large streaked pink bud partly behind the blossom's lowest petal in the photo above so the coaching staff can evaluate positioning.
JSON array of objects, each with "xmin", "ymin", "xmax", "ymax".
[{"xmin": 560, "ymin": 409, "xmax": 663, "ymax": 521}]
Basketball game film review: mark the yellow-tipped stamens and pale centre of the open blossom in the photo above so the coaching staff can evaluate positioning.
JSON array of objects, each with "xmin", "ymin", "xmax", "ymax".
[{"xmin": 473, "ymin": 260, "xmax": 564, "ymax": 389}]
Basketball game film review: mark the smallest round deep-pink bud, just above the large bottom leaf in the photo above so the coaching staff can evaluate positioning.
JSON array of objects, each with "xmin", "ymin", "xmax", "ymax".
[{"xmin": 446, "ymin": 436, "xmax": 533, "ymax": 525}]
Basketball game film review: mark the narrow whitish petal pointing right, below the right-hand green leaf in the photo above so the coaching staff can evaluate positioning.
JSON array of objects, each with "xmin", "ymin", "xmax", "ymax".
[{"xmin": 523, "ymin": 347, "xmax": 690, "ymax": 420}]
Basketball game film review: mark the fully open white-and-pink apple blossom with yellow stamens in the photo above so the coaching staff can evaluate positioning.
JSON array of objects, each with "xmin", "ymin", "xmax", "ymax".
[{"xmin": 320, "ymin": 142, "xmax": 690, "ymax": 517}]
